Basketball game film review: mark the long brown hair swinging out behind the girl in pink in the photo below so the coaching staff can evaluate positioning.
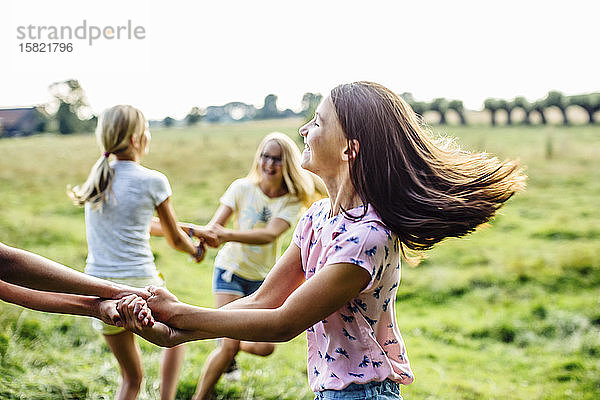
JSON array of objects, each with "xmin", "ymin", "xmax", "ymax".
[{"xmin": 331, "ymin": 82, "xmax": 526, "ymax": 253}]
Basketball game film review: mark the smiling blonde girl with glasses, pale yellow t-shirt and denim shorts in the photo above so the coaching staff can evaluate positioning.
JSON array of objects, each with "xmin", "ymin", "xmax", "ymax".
[{"xmin": 194, "ymin": 132, "xmax": 323, "ymax": 398}]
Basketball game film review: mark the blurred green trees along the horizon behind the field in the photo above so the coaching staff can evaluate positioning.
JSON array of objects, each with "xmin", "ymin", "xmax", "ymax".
[{"xmin": 2, "ymin": 79, "xmax": 600, "ymax": 138}]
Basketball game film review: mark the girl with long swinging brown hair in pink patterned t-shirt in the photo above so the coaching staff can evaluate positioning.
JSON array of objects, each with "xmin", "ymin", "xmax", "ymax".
[{"xmin": 119, "ymin": 82, "xmax": 525, "ymax": 399}]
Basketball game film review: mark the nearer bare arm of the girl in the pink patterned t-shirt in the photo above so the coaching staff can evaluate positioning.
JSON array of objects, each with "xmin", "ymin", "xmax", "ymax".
[{"xmin": 119, "ymin": 244, "xmax": 370, "ymax": 345}]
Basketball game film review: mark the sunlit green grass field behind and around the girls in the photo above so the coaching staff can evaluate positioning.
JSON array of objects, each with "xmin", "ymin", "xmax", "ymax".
[{"xmin": 0, "ymin": 120, "xmax": 600, "ymax": 399}]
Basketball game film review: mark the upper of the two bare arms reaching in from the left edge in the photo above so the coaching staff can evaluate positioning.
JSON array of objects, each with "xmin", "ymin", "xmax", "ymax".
[{"xmin": 0, "ymin": 243, "xmax": 148, "ymax": 299}]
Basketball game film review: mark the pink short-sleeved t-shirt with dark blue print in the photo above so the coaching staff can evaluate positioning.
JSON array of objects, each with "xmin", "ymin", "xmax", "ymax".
[{"xmin": 293, "ymin": 199, "xmax": 414, "ymax": 391}]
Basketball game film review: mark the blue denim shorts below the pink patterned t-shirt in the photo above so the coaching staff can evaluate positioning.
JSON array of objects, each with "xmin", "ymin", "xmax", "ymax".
[{"xmin": 315, "ymin": 379, "xmax": 402, "ymax": 400}]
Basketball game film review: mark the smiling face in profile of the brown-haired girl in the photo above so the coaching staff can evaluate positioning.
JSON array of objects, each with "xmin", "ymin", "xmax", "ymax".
[{"xmin": 299, "ymin": 97, "xmax": 348, "ymax": 178}]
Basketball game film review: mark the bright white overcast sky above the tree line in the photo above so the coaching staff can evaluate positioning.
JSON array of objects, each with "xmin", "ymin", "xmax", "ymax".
[{"xmin": 0, "ymin": 0, "xmax": 600, "ymax": 119}]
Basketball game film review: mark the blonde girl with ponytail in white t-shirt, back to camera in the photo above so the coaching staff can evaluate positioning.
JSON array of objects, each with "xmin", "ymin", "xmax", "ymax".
[{"xmin": 68, "ymin": 105, "xmax": 213, "ymax": 399}]
